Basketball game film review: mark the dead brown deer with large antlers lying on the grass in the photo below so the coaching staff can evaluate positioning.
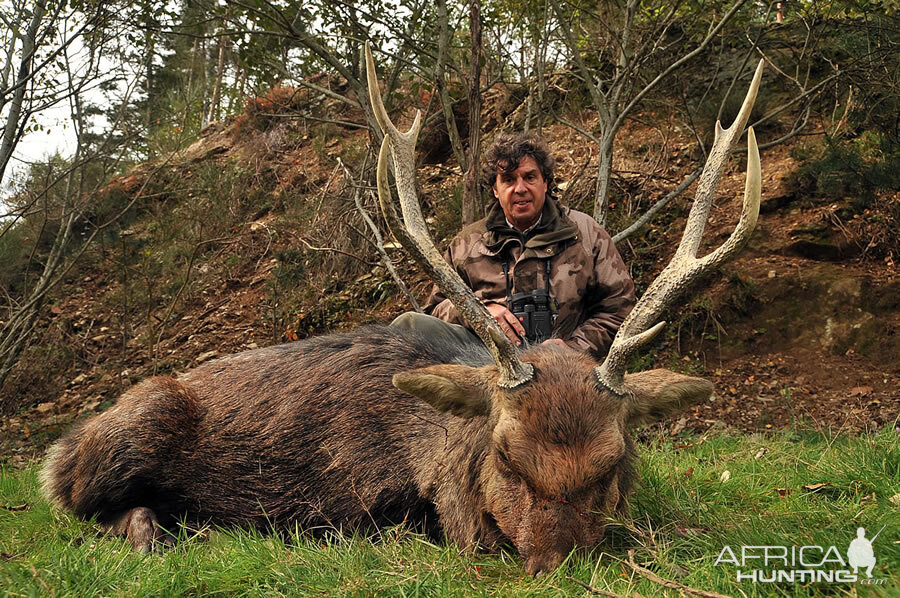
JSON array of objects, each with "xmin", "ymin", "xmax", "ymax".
[{"xmin": 40, "ymin": 44, "xmax": 762, "ymax": 576}]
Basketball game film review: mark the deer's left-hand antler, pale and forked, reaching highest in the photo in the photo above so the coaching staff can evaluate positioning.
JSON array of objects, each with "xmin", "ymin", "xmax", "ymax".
[{"xmin": 366, "ymin": 43, "xmax": 534, "ymax": 389}]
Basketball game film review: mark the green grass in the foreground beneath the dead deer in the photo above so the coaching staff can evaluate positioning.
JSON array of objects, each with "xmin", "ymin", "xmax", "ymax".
[{"xmin": 0, "ymin": 428, "xmax": 900, "ymax": 597}]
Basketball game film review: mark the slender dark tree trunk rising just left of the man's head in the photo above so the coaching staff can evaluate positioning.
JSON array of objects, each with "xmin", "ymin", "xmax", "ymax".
[{"xmin": 462, "ymin": 0, "xmax": 483, "ymax": 226}]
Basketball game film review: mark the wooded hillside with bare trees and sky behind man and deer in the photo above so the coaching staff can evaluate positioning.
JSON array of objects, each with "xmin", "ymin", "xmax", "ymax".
[{"xmin": 0, "ymin": 0, "xmax": 900, "ymax": 446}]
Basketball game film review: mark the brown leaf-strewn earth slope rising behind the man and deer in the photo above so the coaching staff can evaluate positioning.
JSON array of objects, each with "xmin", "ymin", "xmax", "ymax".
[{"xmin": 0, "ymin": 78, "xmax": 900, "ymax": 462}]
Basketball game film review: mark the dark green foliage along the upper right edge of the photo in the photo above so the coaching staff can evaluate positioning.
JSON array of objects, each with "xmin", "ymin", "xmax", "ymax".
[{"xmin": 768, "ymin": 3, "xmax": 900, "ymax": 261}]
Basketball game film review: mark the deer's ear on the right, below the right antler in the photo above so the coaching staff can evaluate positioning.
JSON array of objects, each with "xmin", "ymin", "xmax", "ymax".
[{"xmin": 625, "ymin": 370, "xmax": 713, "ymax": 425}]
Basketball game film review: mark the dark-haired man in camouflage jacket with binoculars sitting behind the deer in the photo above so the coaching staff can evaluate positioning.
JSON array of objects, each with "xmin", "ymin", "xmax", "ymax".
[{"xmin": 393, "ymin": 133, "xmax": 635, "ymax": 359}]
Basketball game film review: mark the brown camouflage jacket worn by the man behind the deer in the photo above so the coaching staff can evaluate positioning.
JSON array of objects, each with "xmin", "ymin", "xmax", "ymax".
[{"xmin": 425, "ymin": 198, "xmax": 635, "ymax": 359}]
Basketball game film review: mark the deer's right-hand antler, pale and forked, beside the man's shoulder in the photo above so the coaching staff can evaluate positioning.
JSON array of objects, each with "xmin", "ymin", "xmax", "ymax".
[{"xmin": 594, "ymin": 60, "xmax": 763, "ymax": 395}]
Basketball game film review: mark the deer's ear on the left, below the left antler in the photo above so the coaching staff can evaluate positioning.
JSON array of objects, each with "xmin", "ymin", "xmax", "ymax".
[{"xmin": 392, "ymin": 364, "xmax": 491, "ymax": 417}]
